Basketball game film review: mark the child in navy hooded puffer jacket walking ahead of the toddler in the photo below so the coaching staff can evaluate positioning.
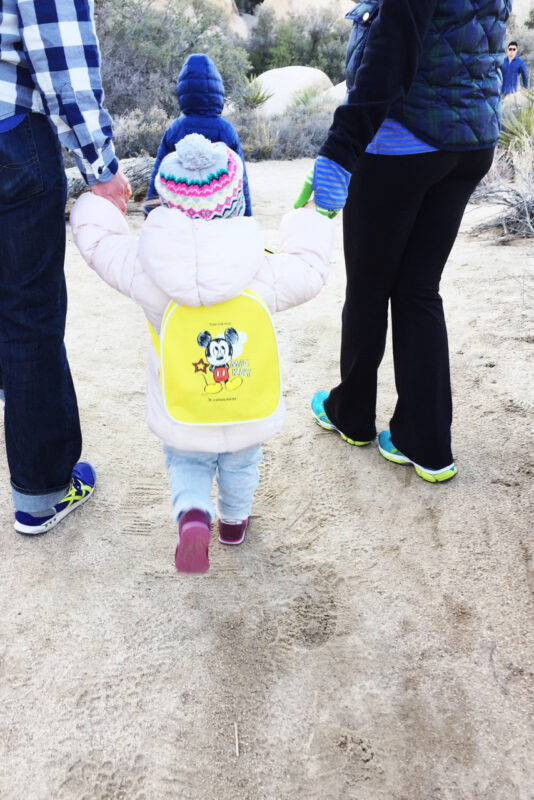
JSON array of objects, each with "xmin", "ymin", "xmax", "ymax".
[{"xmin": 144, "ymin": 53, "xmax": 252, "ymax": 217}]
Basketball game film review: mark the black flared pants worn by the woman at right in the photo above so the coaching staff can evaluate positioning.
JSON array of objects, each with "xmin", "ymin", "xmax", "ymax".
[{"xmin": 325, "ymin": 148, "xmax": 493, "ymax": 469}]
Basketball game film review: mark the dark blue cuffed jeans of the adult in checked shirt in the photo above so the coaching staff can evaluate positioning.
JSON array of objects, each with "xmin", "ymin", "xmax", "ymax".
[{"xmin": 0, "ymin": 114, "xmax": 82, "ymax": 511}]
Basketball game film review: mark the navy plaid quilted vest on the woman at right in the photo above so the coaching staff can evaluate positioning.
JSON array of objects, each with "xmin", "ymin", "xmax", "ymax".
[{"xmin": 346, "ymin": 0, "xmax": 512, "ymax": 150}]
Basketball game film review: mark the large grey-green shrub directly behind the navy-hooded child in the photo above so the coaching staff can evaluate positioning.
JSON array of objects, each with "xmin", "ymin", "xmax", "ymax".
[{"xmin": 95, "ymin": 0, "xmax": 250, "ymax": 117}]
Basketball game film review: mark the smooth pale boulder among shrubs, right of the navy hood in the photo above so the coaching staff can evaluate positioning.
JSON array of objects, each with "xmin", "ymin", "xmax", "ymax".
[{"xmin": 258, "ymin": 67, "xmax": 333, "ymax": 117}]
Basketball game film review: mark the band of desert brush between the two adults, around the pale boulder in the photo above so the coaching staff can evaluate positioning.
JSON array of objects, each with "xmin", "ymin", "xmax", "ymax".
[{"xmin": 90, "ymin": 0, "xmax": 349, "ymax": 160}]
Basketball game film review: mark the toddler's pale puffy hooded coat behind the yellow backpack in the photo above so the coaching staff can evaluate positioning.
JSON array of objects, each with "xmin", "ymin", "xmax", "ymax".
[{"xmin": 70, "ymin": 193, "xmax": 335, "ymax": 453}]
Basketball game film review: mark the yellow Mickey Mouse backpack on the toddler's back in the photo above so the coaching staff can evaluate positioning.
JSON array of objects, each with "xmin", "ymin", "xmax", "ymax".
[{"xmin": 149, "ymin": 289, "xmax": 281, "ymax": 425}]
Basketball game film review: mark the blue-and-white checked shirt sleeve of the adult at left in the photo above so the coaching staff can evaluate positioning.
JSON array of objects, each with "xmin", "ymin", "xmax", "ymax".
[{"xmin": 17, "ymin": 0, "xmax": 118, "ymax": 184}]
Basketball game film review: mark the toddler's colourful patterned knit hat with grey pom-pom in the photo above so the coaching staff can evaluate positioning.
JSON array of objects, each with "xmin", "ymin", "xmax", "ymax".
[{"xmin": 155, "ymin": 133, "xmax": 245, "ymax": 221}]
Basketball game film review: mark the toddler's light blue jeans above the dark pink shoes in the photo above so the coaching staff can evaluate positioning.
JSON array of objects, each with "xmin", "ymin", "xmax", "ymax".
[{"xmin": 163, "ymin": 444, "xmax": 263, "ymax": 520}]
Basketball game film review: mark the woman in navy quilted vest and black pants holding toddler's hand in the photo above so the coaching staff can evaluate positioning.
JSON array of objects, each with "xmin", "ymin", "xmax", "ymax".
[{"xmin": 306, "ymin": 0, "xmax": 511, "ymax": 482}]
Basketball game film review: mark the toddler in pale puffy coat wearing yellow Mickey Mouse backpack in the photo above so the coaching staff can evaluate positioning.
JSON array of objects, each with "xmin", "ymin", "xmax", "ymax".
[{"xmin": 70, "ymin": 134, "xmax": 335, "ymax": 572}]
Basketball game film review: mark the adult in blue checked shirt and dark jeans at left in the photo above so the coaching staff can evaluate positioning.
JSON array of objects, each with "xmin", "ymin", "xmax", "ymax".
[{"xmin": 0, "ymin": 0, "xmax": 130, "ymax": 533}]
